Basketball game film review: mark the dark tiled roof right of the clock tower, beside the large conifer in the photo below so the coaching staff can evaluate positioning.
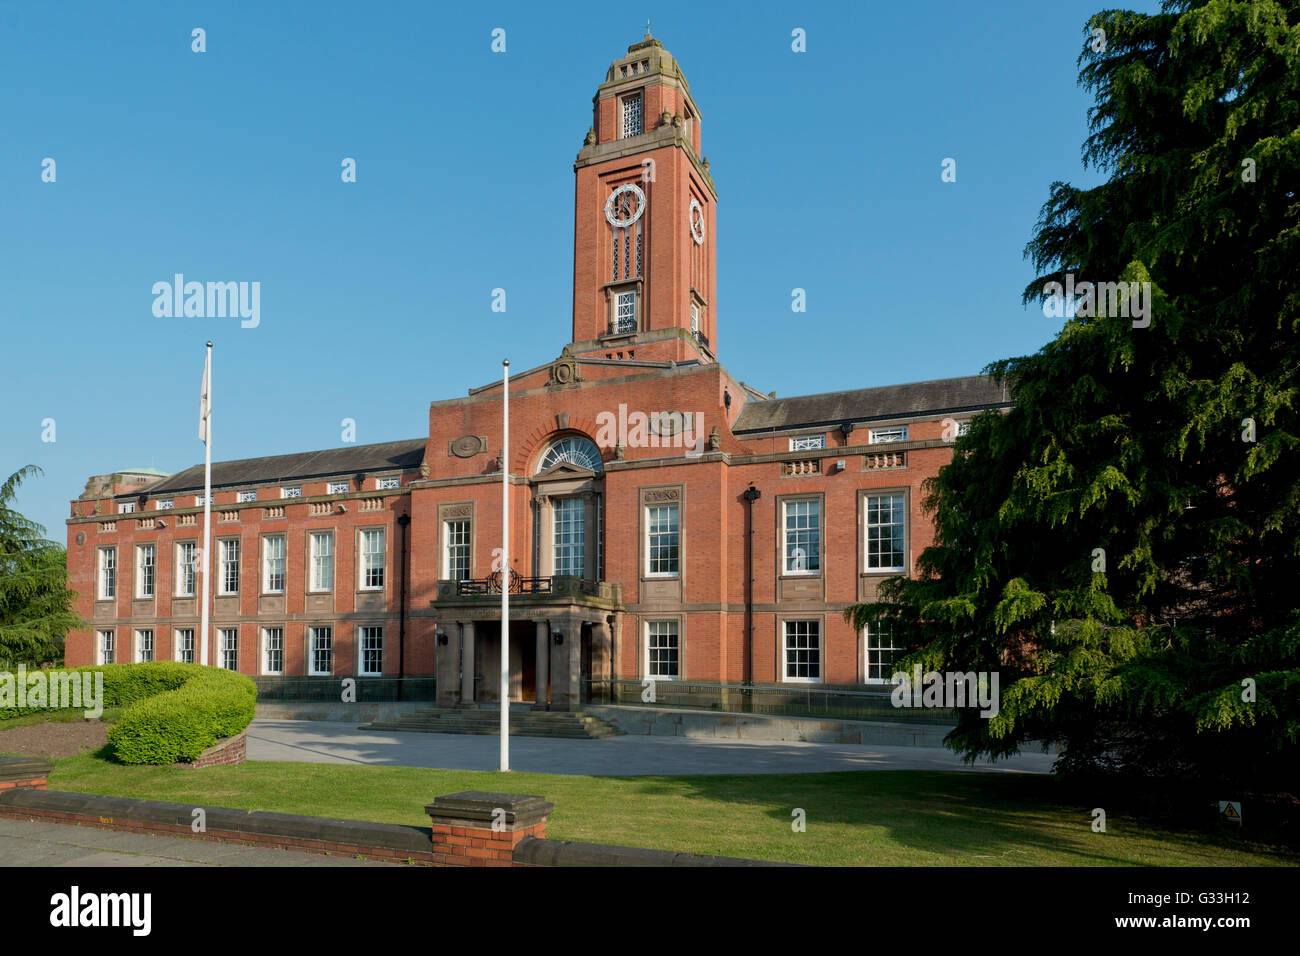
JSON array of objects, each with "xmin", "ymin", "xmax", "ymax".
[{"xmin": 732, "ymin": 375, "xmax": 1010, "ymax": 434}]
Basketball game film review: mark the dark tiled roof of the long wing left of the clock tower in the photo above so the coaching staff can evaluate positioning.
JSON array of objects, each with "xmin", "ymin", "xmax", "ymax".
[{"xmin": 148, "ymin": 438, "xmax": 425, "ymax": 497}]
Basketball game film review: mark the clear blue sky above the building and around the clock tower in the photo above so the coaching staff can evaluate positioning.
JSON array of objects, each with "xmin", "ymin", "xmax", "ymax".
[{"xmin": 0, "ymin": 0, "xmax": 1154, "ymax": 540}]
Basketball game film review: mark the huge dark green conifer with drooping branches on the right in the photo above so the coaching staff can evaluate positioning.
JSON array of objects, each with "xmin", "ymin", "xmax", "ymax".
[{"xmin": 845, "ymin": 0, "xmax": 1300, "ymax": 790}]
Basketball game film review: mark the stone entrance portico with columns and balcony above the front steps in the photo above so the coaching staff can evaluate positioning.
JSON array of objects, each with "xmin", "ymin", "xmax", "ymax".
[{"xmin": 432, "ymin": 575, "xmax": 624, "ymax": 711}]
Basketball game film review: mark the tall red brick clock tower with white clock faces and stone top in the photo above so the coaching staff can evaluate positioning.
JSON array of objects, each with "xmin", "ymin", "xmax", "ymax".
[{"xmin": 572, "ymin": 31, "xmax": 718, "ymax": 362}]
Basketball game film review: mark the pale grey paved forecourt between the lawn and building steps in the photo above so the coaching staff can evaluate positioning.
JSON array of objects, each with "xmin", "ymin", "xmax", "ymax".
[{"xmin": 247, "ymin": 718, "xmax": 1056, "ymax": 777}]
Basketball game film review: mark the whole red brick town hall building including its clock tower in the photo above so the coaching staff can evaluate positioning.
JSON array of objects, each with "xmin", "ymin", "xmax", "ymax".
[{"xmin": 66, "ymin": 38, "xmax": 1008, "ymax": 710}]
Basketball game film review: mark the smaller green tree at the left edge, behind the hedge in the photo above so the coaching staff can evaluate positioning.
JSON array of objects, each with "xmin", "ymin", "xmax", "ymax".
[{"xmin": 0, "ymin": 464, "xmax": 85, "ymax": 666}]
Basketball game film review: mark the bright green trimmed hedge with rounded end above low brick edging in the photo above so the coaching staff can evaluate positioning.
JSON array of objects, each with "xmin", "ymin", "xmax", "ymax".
[{"xmin": 0, "ymin": 661, "xmax": 257, "ymax": 763}]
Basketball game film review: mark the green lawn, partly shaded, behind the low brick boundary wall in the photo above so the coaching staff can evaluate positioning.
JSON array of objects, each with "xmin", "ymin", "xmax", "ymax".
[{"xmin": 49, "ymin": 754, "xmax": 1300, "ymax": 866}]
